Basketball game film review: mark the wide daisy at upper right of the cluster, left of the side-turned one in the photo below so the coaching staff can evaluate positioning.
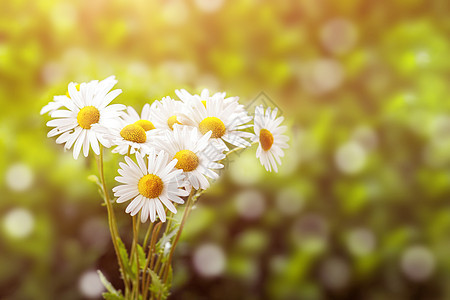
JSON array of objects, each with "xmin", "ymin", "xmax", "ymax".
[{"xmin": 178, "ymin": 92, "xmax": 253, "ymax": 150}]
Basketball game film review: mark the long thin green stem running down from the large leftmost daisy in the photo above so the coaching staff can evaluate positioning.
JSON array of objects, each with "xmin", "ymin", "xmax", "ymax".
[{"xmin": 96, "ymin": 145, "xmax": 130, "ymax": 295}]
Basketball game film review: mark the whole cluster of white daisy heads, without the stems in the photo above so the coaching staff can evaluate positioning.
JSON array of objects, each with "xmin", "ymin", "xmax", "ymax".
[{"xmin": 41, "ymin": 76, "xmax": 288, "ymax": 222}]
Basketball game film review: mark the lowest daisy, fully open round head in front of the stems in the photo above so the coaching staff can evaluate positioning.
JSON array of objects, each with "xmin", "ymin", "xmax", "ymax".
[{"xmin": 113, "ymin": 150, "xmax": 189, "ymax": 223}]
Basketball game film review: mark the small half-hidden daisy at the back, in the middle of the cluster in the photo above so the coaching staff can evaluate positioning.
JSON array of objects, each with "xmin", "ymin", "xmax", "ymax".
[{"xmin": 152, "ymin": 97, "xmax": 184, "ymax": 130}]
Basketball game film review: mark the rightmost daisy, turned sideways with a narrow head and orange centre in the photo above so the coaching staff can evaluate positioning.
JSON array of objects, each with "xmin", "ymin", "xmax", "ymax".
[{"xmin": 253, "ymin": 105, "xmax": 289, "ymax": 172}]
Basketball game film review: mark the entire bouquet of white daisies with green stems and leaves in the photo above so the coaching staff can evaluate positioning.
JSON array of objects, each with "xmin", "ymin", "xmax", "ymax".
[{"xmin": 41, "ymin": 76, "xmax": 288, "ymax": 300}]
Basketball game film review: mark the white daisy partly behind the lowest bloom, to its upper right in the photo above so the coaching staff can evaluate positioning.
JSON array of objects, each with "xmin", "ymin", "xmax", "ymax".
[{"xmin": 155, "ymin": 124, "xmax": 225, "ymax": 189}]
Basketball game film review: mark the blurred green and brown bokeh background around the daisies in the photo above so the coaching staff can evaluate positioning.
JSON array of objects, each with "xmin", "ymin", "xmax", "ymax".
[{"xmin": 0, "ymin": 0, "xmax": 450, "ymax": 299}]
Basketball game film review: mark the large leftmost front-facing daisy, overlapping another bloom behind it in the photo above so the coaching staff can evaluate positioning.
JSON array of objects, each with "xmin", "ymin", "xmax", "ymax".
[{"xmin": 47, "ymin": 77, "xmax": 125, "ymax": 159}]
